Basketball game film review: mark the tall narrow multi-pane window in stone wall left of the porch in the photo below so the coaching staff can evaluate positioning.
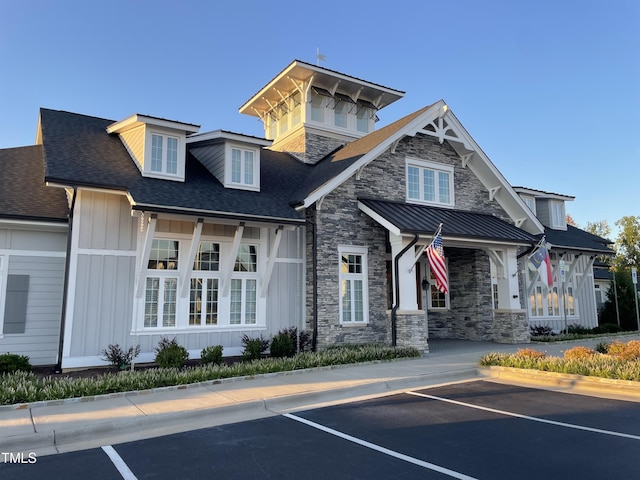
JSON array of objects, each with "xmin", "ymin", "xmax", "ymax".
[{"xmin": 339, "ymin": 247, "xmax": 368, "ymax": 323}]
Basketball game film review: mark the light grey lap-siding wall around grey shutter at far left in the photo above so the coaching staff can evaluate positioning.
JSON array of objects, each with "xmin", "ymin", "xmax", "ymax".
[{"xmin": 0, "ymin": 225, "xmax": 67, "ymax": 365}]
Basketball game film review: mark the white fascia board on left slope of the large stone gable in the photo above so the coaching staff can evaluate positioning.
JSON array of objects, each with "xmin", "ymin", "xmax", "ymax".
[{"xmin": 304, "ymin": 100, "xmax": 447, "ymax": 208}]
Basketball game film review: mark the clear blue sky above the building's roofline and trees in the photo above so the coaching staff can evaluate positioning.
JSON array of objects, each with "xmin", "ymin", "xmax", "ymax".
[{"xmin": 0, "ymin": 0, "xmax": 640, "ymax": 239}]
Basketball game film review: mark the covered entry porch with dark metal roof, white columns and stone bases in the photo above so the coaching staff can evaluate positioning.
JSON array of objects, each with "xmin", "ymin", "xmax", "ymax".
[{"xmin": 360, "ymin": 199, "xmax": 537, "ymax": 351}]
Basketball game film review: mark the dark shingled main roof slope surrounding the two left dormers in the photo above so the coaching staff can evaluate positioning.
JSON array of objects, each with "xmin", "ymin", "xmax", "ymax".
[{"xmin": 40, "ymin": 109, "xmax": 309, "ymax": 223}]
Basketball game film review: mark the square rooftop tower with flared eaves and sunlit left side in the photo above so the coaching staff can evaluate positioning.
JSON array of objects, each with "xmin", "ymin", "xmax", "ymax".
[{"xmin": 240, "ymin": 60, "xmax": 404, "ymax": 163}]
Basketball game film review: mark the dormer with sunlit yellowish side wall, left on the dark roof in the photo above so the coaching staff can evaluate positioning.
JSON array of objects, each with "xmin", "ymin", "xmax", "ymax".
[{"xmin": 107, "ymin": 113, "xmax": 200, "ymax": 182}]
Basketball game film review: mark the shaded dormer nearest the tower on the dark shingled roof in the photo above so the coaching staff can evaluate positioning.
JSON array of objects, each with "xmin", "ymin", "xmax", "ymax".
[{"xmin": 187, "ymin": 130, "xmax": 271, "ymax": 191}]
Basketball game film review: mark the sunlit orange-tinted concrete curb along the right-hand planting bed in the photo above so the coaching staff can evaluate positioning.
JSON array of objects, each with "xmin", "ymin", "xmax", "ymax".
[{"xmin": 478, "ymin": 366, "xmax": 640, "ymax": 402}]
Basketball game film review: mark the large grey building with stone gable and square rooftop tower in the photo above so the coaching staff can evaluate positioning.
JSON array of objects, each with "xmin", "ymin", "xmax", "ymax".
[{"xmin": 0, "ymin": 60, "xmax": 602, "ymax": 368}]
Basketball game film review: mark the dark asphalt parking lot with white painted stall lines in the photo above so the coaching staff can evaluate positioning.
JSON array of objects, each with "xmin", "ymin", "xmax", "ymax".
[{"xmin": 0, "ymin": 381, "xmax": 640, "ymax": 480}]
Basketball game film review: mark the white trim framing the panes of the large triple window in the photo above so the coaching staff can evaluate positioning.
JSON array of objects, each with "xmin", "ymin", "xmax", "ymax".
[{"xmin": 132, "ymin": 232, "xmax": 266, "ymax": 335}]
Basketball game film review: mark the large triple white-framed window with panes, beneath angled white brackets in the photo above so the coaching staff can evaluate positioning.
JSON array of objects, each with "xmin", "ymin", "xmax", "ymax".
[{"xmin": 140, "ymin": 238, "xmax": 264, "ymax": 331}]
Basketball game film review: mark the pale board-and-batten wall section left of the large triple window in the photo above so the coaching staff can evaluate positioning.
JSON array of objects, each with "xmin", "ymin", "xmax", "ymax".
[{"xmin": 62, "ymin": 190, "xmax": 139, "ymax": 368}]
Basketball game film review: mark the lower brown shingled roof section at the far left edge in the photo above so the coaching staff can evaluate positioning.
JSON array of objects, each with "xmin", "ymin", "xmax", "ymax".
[{"xmin": 0, "ymin": 145, "xmax": 69, "ymax": 222}]
